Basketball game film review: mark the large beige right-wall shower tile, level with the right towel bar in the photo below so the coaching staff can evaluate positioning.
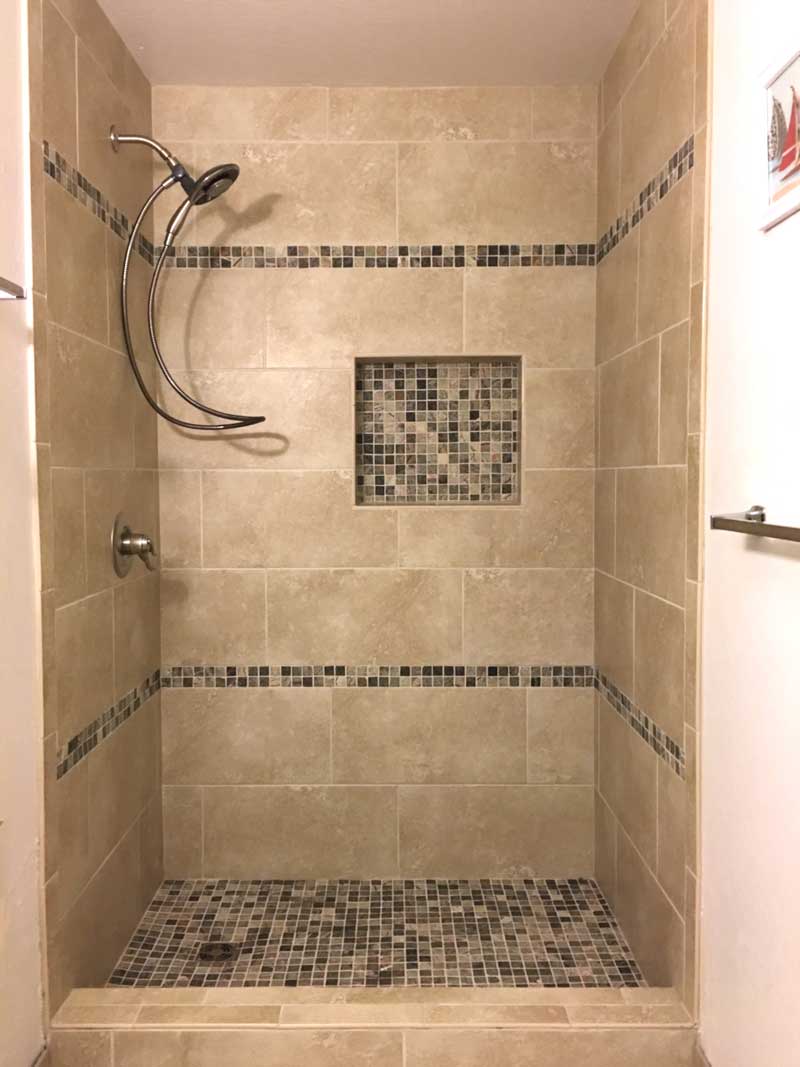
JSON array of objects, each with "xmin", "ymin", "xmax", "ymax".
[{"xmin": 617, "ymin": 467, "xmax": 686, "ymax": 604}]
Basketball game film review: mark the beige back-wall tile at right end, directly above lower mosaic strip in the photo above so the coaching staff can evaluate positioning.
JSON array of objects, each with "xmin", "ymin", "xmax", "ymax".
[{"xmin": 464, "ymin": 570, "xmax": 593, "ymax": 664}]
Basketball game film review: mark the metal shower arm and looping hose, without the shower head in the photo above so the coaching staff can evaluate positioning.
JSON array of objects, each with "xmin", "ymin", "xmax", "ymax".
[{"xmin": 122, "ymin": 174, "xmax": 265, "ymax": 432}]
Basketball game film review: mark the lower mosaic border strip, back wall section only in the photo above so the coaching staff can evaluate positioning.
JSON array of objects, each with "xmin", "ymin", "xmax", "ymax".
[{"xmin": 161, "ymin": 664, "xmax": 595, "ymax": 689}]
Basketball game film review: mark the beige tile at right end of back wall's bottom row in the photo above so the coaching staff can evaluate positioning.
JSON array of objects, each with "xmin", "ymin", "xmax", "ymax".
[{"xmin": 399, "ymin": 785, "xmax": 594, "ymax": 878}]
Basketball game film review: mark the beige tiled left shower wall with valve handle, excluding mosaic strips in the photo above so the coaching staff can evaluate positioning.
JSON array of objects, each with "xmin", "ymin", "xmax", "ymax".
[{"xmin": 29, "ymin": 0, "xmax": 161, "ymax": 1010}]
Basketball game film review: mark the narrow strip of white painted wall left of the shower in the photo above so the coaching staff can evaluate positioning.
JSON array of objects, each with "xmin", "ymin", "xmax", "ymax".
[{"xmin": 0, "ymin": 0, "xmax": 43, "ymax": 1067}]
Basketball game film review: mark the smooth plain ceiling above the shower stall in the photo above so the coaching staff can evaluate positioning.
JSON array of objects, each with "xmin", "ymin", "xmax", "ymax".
[{"xmin": 100, "ymin": 0, "xmax": 638, "ymax": 85}]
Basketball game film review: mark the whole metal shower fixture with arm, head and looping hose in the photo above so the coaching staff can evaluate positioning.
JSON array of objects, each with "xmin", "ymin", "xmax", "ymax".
[{"xmin": 110, "ymin": 126, "xmax": 265, "ymax": 431}]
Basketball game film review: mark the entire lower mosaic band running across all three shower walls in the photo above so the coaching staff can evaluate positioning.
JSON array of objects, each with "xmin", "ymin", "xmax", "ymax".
[{"xmin": 55, "ymin": 664, "xmax": 686, "ymax": 778}]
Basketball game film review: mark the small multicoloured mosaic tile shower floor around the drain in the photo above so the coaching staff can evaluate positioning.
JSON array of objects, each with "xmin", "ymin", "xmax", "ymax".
[{"xmin": 109, "ymin": 879, "xmax": 645, "ymax": 988}]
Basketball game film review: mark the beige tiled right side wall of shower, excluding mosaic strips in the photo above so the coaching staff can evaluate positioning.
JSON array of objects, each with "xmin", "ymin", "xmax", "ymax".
[{"xmin": 595, "ymin": 0, "xmax": 708, "ymax": 1009}]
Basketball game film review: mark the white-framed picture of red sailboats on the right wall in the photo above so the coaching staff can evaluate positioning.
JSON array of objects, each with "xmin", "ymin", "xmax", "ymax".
[{"xmin": 762, "ymin": 52, "xmax": 800, "ymax": 230}]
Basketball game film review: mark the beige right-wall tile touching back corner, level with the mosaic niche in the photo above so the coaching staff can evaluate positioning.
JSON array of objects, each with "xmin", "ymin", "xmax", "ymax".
[{"xmin": 597, "ymin": 338, "xmax": 659, "ymax": 466}]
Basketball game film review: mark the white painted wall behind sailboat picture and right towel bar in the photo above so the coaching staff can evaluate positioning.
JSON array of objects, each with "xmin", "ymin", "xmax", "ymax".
[{"xmin": 701, "ymin": 0, "xmax": 800, "ymax": 1067}]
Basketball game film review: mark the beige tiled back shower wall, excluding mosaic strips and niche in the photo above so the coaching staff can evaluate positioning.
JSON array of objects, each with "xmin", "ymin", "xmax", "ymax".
[{"xmin": 154, "ymin": 87, "xmax": 597, "ymax": 877}]
